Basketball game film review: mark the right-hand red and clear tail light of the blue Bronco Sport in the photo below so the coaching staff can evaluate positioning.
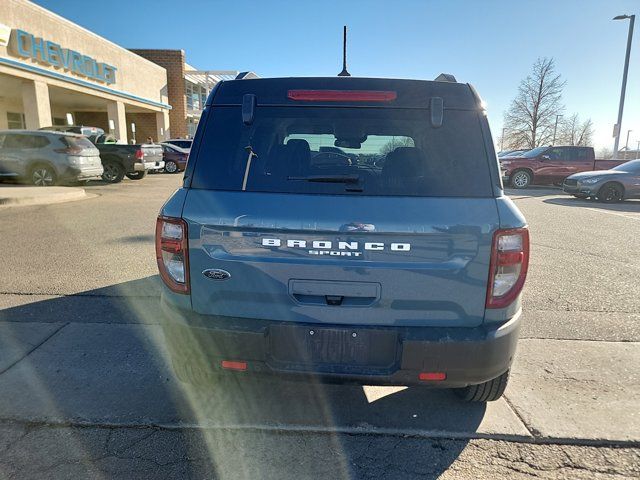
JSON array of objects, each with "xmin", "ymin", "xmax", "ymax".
[{"xmin": 486, "ymin": 228, "xmax": 529, "ymax": 308}]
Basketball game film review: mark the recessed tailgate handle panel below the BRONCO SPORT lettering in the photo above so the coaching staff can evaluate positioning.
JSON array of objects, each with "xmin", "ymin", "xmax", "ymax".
[{"xmin": 289, "ymin": 279, "xmax": 381, "ymax": 306}]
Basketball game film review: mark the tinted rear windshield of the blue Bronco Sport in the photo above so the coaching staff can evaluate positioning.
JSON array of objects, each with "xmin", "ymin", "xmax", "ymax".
[{"xmin": 191, "ymin": 106, "xmax": 492, "ymax": 197}]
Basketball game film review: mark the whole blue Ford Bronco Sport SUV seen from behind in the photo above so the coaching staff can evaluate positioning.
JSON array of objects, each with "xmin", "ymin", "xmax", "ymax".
[{"xmin": 156, "ymin": 77, "xmax": 529, "ymax": 401}]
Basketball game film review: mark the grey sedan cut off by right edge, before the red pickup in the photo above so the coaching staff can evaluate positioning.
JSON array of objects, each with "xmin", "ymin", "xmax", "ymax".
[{"xmin": 562, "ymin": 160, "xmax": 640, "ymax": 203}]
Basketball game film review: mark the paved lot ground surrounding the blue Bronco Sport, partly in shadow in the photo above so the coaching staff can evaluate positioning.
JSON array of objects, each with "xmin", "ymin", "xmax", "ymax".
[{"xmin": 0, "ymin": 175, "xmax": 640, "ymax": 478}]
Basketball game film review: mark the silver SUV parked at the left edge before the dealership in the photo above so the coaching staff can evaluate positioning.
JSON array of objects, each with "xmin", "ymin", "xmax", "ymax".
[{"xmin": 0, "ymin": 130, "xmax": 103, "ymax": 187}]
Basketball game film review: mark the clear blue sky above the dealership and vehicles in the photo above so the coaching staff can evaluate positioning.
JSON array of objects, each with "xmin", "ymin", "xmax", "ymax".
[{"xmin": 36, "ymin": 0, "xmax": 640, "ymax": 152}]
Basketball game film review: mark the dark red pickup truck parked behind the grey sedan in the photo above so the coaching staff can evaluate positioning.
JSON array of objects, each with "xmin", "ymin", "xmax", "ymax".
[{"xmin": 499, "ymin": 146, "xmax": 625, "ymax": 188}]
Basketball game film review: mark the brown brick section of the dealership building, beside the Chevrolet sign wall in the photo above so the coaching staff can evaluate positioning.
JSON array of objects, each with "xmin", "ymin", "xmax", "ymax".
[{"xmin": 131, "ymin": 49, "xmax": 189, "ymax": 140}]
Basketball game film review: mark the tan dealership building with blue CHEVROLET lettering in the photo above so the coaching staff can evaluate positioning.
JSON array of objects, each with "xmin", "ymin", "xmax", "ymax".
[{"xmin": 0, "ymin": 0, "xmax": 254, "ymax": 142}]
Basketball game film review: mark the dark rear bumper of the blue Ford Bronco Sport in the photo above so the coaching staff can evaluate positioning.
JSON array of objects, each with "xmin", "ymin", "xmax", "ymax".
[{"xmin": 162, "ymin": 298, "xmax": 520, "ymax": 387}]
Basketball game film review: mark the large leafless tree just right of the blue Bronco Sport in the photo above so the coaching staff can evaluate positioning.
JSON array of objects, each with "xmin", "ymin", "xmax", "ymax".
[{"xmin": 504, "ymin": 58, "xmax": 566, "ymax": 148}]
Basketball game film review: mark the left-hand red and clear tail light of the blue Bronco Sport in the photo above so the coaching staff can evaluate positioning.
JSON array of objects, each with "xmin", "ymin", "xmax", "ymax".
[{"xmin": 156, "ymin": 216, "xmax": 190, "ymax": 294}]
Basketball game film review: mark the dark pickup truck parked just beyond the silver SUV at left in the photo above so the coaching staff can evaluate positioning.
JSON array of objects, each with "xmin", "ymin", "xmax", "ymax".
[{"xmin": 40, "ymin": 125, "xmax": 164, "ymax": 183}]
